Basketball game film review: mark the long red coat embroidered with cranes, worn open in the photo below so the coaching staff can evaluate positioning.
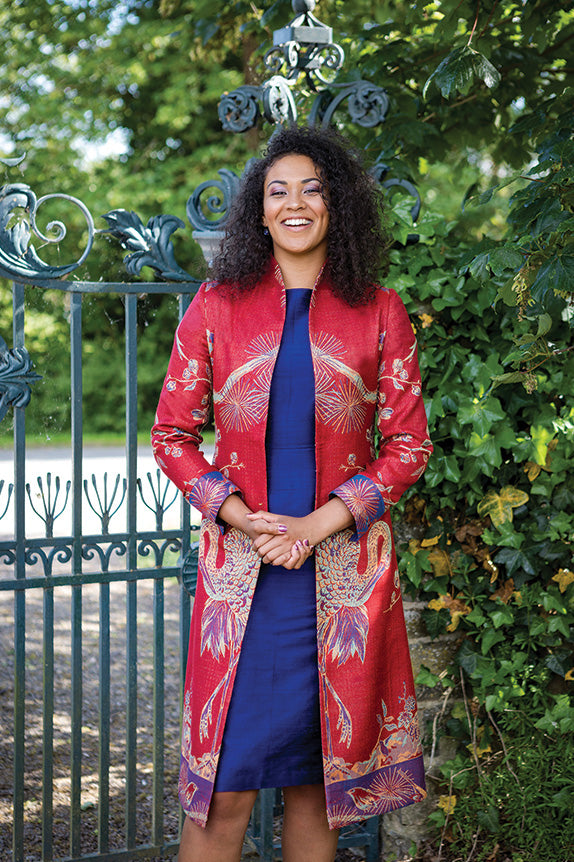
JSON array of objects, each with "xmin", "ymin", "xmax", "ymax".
[{"xmin": 152, "ymin": 266, "xmax": 432, "ymax": 828}]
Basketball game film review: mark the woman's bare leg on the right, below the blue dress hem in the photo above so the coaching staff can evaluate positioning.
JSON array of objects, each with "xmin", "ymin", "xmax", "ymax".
[{"xmin": 282, "ymin": 784, "xmax": 339, "ymax": 862}]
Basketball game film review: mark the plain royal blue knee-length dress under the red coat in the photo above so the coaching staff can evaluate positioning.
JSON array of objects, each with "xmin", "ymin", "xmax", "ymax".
[{"xmin": 215, "ymin": 288, "xmax": 323, "ymax": 791}]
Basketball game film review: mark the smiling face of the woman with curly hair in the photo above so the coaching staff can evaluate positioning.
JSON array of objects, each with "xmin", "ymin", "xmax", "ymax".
[{"xmin": 263, "ymin": 155, "xmax": 329, "ymax": 268}]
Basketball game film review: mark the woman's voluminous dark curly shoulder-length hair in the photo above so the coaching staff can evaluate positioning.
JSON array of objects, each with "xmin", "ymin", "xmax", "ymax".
[{"xmin": 211, "ymin": 126, "xmax": 389, "ymax": 305}]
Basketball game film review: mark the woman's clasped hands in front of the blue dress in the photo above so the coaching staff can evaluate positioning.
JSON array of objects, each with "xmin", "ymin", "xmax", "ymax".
[{"xmin": 245, "ymin": 510, "xmax": 313, "ymax": 569}]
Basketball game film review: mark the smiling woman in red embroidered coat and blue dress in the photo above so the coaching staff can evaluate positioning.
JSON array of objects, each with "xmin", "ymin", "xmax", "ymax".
[{"xmin": 153, "ymin": 127, "xmax": 431, "ymax": 862}]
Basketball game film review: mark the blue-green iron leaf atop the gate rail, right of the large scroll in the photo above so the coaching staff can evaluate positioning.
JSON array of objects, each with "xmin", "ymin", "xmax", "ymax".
[{"xmin": 102, "ymin": 209, "xmax": 195, "ymax": 281}]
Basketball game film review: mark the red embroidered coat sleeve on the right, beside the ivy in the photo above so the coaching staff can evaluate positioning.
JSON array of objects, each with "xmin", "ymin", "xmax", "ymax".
[{"xmin": 332, "ymin": 290, "xmax": 432, "ymax": 536}]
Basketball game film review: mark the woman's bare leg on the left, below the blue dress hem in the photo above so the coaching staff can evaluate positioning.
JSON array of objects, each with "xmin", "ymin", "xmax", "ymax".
[{"xmin": 177, "ymin": 790, "xmax": 257, "ymax": 862}]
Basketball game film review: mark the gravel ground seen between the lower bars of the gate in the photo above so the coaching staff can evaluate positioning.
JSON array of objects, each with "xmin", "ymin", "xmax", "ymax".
[{"xmin": 0, "ymin": 570, "xmax": 364, "ymax": 862}]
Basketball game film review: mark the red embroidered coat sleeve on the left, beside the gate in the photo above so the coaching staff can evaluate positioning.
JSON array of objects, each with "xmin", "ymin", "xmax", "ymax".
[{"xmin": 152, "ymin": 285, "xmax": 239, "ymax": 520}]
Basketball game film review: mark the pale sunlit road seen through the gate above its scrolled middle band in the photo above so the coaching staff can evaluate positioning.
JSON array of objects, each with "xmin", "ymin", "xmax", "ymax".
[{"xmin": 0, "ymin": 446, "xmax": 211, "ymax": 538}]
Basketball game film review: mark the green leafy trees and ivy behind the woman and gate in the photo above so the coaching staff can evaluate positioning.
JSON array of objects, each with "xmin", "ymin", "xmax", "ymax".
[{"xmin": 0, "ymin": 0, "xmax": 574, "ymax": 862}]
